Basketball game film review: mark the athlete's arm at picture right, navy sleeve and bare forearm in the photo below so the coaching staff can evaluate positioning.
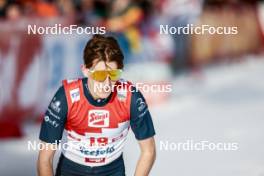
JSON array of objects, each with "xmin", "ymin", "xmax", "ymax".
[{"xmin": 130, "ymin": 89, "xmax": 156, "ymax": 176}]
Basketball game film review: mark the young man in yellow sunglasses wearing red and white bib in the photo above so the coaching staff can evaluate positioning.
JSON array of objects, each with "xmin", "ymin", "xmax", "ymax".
[{"xmin": 38, "ymin": 35, "xmax": 155, "ymax": 176}]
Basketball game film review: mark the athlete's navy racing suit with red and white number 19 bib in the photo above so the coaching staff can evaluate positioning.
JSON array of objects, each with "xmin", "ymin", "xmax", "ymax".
[{"xmin": 39, "ymin": 78, "xmax": 155, "ymax": 176}]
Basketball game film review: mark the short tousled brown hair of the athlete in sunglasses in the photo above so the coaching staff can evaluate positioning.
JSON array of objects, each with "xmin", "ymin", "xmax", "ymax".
[{"xmin": 83, "ymin": 34, "xmax": 124, "ymax": 69}]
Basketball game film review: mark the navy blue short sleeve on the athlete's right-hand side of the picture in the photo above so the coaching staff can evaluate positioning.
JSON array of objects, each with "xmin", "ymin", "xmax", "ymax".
[{"xmin": 130, "ymin": 88, "xmax": 155, "ymax": 140}]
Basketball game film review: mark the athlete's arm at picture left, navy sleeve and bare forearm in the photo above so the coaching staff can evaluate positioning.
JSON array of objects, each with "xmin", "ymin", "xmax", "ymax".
[{"xmin": 37, "ymin": 87, "xmax": 68, "ymax": 176}]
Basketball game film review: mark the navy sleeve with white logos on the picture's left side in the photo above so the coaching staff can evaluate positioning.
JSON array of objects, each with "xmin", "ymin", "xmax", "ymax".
[{"xmin": 39, "ymin": 86, "xmax": 68, "ymax": 143}]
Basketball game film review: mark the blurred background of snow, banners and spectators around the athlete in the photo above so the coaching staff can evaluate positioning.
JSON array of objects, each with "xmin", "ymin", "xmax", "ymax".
[{"xmin": 0, "ymin": 0, "xmax": 264, "ymax": 176}]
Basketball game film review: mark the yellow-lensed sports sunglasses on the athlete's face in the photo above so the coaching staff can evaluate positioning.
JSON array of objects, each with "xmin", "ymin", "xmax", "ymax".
[{"xmin": 89, "ymin": 69, "xmax": 122, "ymax": 82}]
